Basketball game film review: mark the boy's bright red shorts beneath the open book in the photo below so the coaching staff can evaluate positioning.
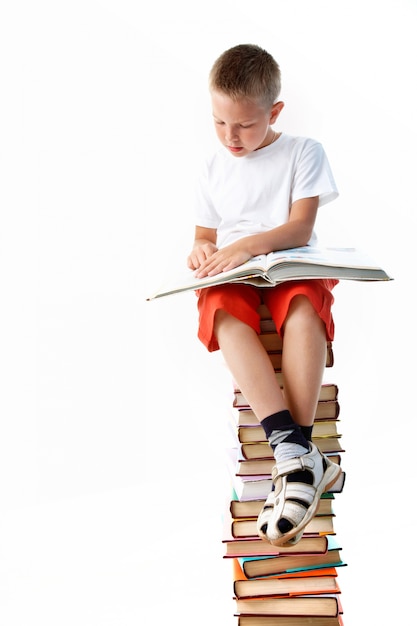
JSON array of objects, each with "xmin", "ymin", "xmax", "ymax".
[{"xmin": 196, "ymin": 279, "xmax": 339, "ymax": 352}]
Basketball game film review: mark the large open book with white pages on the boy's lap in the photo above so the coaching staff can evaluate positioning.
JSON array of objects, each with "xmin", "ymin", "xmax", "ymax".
[{"xmin": 147, "ymin": 246, "xmax": 392, "ymax": 300}]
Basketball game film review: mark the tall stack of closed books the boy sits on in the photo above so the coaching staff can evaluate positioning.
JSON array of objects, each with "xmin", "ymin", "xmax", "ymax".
[{"xmin": 223, "ymin": 305, "xmax": 346, "ymax": 626}]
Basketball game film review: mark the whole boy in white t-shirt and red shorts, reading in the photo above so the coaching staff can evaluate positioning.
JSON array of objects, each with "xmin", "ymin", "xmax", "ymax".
[{"xmin": 187, "ymin": 45, "xmax": 340, "ymax": 546}]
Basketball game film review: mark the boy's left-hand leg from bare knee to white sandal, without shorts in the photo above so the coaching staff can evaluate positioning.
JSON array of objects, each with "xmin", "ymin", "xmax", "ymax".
[{"xmin": 214, "ymin": 307, "xmax": 340, "ymax": 545}]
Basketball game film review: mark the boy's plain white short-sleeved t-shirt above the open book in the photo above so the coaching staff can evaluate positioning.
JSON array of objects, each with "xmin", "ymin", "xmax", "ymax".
[{"xmin": 195, "ymin": 133, "xmax": 338, "ymax": 248}]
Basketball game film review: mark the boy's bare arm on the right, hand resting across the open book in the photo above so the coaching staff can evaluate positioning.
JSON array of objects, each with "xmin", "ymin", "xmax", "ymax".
[{"xmin": 190, "ymin": 196, "xmax": 319, "ymax": 278}]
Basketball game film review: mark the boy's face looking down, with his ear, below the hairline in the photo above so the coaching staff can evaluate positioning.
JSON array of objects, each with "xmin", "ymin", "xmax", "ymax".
[{"xmin": 211, "ymin": 91, "xmax": 284, "ymax": 157}]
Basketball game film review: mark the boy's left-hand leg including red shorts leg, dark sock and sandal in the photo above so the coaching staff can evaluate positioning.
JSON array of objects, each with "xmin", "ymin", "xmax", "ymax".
[{"xmin": 199, "ymin": 285, "xmax": 340, "ymax": 545}]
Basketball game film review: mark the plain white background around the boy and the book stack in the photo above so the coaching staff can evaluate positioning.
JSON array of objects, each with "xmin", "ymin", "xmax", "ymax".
[{"xmin": 0, "ymin": 0, "xmax": 417, "ymax": 626}]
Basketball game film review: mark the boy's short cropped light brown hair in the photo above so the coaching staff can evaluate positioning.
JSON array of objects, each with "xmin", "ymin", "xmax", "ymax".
[{"xmin": 209, "ymin": 44, "xmax": 281, "ymax": 107}]
